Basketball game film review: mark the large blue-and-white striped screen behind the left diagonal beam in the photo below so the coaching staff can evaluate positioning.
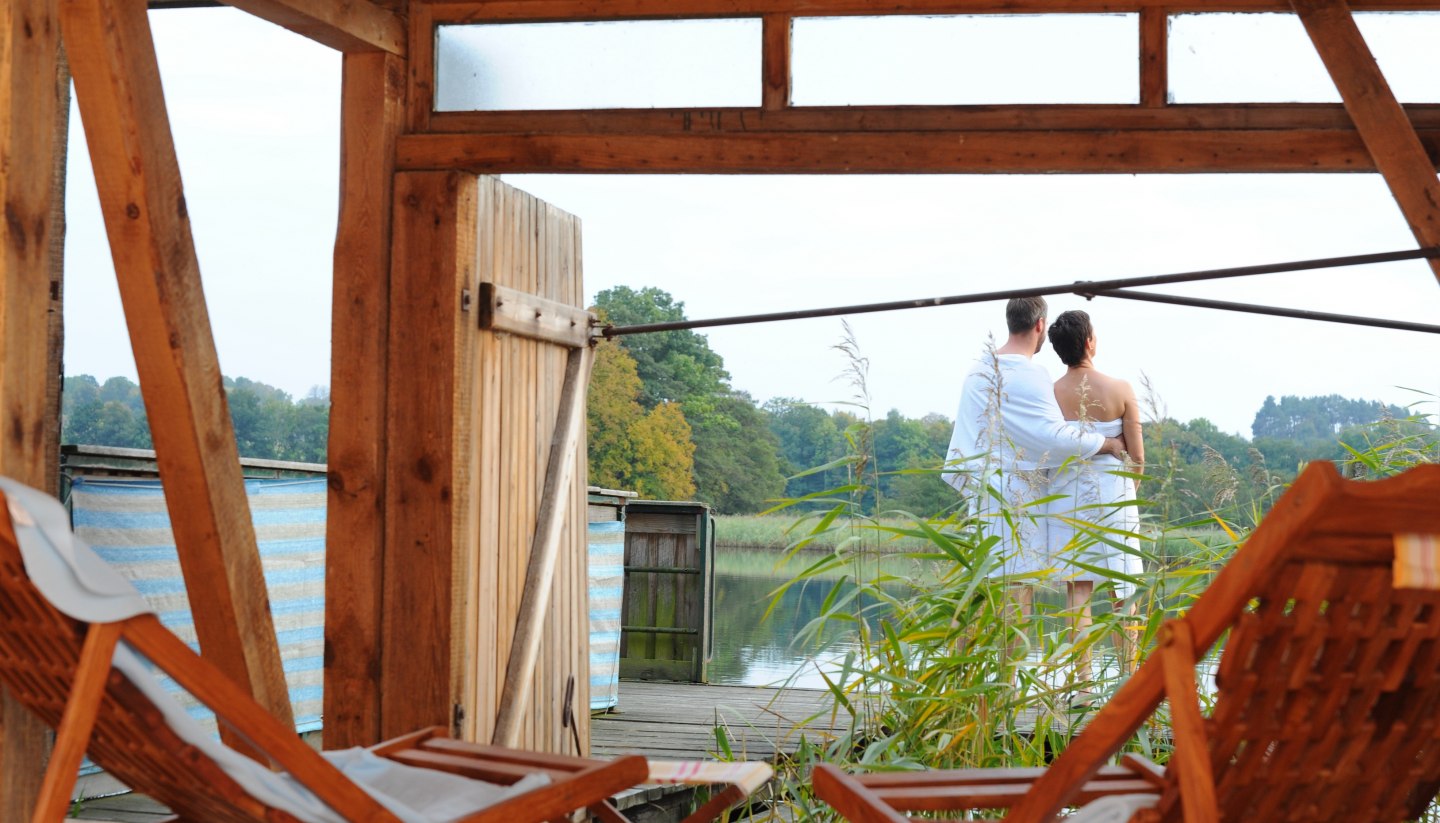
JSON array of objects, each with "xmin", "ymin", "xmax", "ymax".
[{"xmin": 71, "ymin": 478, "xmax": 325, "ymax": 732}]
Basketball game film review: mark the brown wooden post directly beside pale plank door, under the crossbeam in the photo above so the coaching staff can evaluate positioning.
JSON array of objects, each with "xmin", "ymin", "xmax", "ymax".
[{"xmin": 380, "ymin": 173, "xmax": 480, "ymax": 738}]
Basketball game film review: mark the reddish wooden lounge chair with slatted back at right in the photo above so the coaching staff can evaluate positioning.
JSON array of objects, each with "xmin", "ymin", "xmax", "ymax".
[{"xmin": 814, "ymin": 463, "xmax": 1440, "ymax": 823}]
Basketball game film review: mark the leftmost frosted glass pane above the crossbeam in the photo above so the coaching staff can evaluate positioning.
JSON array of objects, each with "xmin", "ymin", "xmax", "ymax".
[{"xmin": 435, "ymin": 19, "xmax": 760, "ymax": 111}]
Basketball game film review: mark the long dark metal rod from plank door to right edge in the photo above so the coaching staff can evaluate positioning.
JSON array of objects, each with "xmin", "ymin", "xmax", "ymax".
[{"xmin": 596, "ymin": 246, "xmax": 1440, "ymax": 338}]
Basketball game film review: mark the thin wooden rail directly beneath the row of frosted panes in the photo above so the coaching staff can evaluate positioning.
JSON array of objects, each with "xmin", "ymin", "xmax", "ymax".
[{"xmin": 426, "ymin": 104, "xmax": 1440, "ymax": 135}]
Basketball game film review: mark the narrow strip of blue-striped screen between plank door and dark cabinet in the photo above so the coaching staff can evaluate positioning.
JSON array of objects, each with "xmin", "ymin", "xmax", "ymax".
[{"xmin": 589, "ymin": 521, "xmax": 625, "ymax": 711}]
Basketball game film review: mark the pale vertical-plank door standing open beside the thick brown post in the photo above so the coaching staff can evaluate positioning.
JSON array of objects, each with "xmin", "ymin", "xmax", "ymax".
[{"xmin": 462, "ymin": 177, "xmax": 590, "ymax": 752}]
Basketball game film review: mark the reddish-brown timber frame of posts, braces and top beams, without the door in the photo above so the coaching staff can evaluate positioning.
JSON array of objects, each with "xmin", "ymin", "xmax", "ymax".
[{"xmin": 0, "ymin": 0, "xmax": 1440, "ymax": 819}]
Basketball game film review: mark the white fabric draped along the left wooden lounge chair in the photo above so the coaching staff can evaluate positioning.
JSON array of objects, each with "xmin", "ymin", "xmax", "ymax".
[{"xmin": 0, "ymin": 478, "xmax": 550, "ymax": 823}]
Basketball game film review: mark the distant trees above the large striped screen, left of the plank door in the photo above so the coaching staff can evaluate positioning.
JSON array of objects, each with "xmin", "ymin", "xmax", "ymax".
[{"xmin": 60, "ymin": 374, "xmax": 330, "ymax": 463}]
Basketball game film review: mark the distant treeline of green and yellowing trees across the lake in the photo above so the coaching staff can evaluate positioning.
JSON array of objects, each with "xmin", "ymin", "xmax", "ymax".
[{"xmin": 63, "ymin": 286, "xmax": 1436, "ymax": 522}]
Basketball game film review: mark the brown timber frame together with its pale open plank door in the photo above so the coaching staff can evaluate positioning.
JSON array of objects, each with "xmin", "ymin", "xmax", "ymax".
[{"xmin": 8, "ymin": 0, "xmax": 1440, "ymax": 799}]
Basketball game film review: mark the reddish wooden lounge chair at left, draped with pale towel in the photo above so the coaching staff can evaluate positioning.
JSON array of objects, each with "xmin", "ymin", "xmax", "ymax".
[{"xmin": 0, "ymin": 481, "xmax": 769, "ymax": 823}]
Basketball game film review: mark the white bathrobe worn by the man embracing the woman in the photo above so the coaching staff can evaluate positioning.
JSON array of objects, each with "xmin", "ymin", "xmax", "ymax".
[{"xmin": 945, "ymin": 353, "xmax": 1104, "ymax": 574}]
